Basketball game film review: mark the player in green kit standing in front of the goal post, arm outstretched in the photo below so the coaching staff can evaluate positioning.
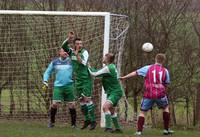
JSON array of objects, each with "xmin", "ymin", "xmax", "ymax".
[{"xmin": 89, "ymin": 53, "xmax": 123, "ymax": 133}]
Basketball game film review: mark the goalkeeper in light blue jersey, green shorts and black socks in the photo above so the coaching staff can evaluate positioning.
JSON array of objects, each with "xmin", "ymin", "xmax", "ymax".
[{"xmin": 43, "ymin": 48, "xmax": 76, "ymax": 128}]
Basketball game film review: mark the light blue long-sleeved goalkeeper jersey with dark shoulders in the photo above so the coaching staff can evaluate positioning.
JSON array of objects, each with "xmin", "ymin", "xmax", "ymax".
[{"xmin": 43, "ymin": 57, "xmax": 73, "ymax": 87}]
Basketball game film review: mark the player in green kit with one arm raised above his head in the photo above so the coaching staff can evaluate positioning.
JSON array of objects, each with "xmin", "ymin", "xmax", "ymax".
[{"xmin": 62, "ymin": 32, "xmax": 96, "ymax": 130}]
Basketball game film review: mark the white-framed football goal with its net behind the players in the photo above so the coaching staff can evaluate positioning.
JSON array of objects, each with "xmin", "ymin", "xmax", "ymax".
[{"xmin": 0, "ymin": 11, "xmax": 129, "ymax": 126}]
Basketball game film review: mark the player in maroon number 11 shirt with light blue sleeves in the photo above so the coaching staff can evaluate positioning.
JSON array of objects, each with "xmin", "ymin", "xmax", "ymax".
[{"xmin": 120, "ymin": 53, "xmax": 173, "ymax": 135}]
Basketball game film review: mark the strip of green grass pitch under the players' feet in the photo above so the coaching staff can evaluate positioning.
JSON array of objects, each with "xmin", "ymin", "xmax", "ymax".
[{"xmin": 0, "ymin": 120, "xmax": 200, "ymax": 137}]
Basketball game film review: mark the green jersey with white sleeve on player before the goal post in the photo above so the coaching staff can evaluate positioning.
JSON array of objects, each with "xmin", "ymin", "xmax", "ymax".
[{"xmin": 89, "ymin": 64, "xmax": 123, "ymax": 95}]
